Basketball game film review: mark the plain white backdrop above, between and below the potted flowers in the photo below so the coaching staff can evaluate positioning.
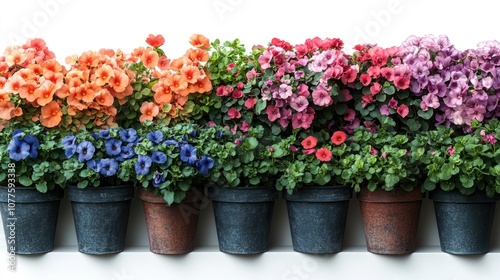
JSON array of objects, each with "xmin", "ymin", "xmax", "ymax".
[{"xmin": 0, "ymin": 0, "xmax": 500, "ymax": 280}]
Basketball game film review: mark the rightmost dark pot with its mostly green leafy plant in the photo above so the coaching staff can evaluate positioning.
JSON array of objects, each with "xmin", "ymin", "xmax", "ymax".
[{"xmin": 412, "ymin": 120, "xmax": 500, "ymax": 255}]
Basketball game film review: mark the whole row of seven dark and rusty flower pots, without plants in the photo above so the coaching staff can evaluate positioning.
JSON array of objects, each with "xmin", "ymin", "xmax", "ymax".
[{"xmin": 0, "ymin": 186, "xmax": 496, "ymax": 255}]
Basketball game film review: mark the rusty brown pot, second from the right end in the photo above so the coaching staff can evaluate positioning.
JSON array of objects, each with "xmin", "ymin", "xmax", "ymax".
[{"xmin": 358, "ymin": 188, "xmax": 424, "ymax": 255}]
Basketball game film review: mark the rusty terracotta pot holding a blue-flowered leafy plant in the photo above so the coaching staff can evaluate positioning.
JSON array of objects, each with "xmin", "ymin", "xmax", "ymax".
[{"xmin": 130, "ymin": 122, "xmax": 223, "ymax": 254}]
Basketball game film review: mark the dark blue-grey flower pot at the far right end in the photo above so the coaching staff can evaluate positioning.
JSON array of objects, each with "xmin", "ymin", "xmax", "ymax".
[{"xmin": 429, "ymin": 190, "xmax": 496, "ymax": 255}]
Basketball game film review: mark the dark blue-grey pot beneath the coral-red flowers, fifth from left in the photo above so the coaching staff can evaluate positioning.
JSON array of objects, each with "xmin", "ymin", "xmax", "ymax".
[{"xmin": 283, "ymin": 186, "xmax": 352, "ymax": 254}]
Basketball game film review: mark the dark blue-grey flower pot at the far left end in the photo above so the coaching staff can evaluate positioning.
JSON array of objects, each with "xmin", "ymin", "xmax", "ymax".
[{"xmin": 0, "ymin": 187, "xmax": 64, "ymax": 255}]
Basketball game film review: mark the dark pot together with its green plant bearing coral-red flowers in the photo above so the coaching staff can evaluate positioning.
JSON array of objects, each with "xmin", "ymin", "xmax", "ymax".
[{"xmin": 274, "ymin": 130, "xmax": 352, "ymax": 254}]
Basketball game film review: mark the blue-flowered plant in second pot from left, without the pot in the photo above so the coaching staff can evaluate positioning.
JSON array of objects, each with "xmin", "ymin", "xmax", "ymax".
[{"xmin": 61, "ymin": 128, "xmax": 139, "ymax": 189}]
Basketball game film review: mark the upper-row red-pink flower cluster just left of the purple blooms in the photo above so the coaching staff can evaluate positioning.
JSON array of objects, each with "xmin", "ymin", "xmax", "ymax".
[{"xmin": 353, "ymin": 45, "xmax": 426, "ymax": 132}]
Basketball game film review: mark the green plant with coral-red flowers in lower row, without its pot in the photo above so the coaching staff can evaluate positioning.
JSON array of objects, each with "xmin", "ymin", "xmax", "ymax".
[{"xmin": 276, "ymin": 130, "xmax": 350, "ymax": 194}]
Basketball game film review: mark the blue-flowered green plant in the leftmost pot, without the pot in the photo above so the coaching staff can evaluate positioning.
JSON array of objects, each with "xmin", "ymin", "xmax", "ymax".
[{"xmin": 0, "ymin": 123, "xmax": 66, "ymax": 193}]
